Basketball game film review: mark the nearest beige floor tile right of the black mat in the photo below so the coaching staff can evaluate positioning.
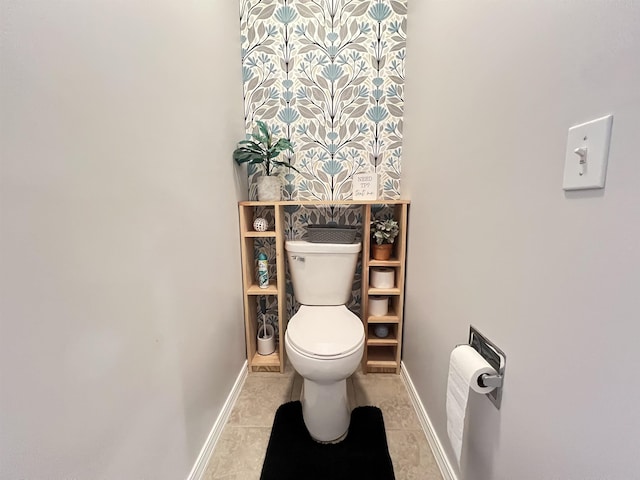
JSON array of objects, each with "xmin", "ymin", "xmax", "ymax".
[{"xmin": 387, "ymin": 430, "xmax": 442, "ymax": 480}]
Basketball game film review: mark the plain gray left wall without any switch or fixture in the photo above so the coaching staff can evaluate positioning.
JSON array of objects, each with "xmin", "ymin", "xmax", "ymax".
[{"xmin": 0, "ymin": 0, "xmax": 246, "ymax": 480}]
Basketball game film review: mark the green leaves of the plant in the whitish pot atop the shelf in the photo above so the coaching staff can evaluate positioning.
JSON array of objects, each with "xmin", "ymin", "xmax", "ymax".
[{"xmin": 233, "ymin": 120, "xmax": 298, "ymax": 176}]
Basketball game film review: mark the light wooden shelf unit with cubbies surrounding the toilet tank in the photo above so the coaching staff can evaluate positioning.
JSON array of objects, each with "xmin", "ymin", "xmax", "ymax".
[{"xmin": 238, "ymin": 200, "xmax": 409, "ymax": 373}]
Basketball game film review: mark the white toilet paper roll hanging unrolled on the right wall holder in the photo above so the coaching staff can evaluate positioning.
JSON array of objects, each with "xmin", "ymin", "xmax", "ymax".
[{"xmin": 447, "ymin": 345, "xmax": 496, "ymax": 464}]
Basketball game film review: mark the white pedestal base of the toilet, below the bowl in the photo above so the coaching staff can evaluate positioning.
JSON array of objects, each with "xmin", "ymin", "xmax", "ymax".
[{"xmin": 300, "ymin": 378, "xmax": 351, "ymax": 443}]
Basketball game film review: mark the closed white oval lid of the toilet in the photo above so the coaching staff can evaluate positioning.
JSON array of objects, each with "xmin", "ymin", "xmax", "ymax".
[{"xmin": 287, "ymin": 305, "xmax": 364, "ymax": 357}]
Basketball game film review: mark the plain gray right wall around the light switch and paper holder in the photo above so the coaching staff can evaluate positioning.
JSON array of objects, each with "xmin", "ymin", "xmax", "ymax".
[{"xmin": 402, "ymin": 0, "xmax": 640, "ymax": 480}]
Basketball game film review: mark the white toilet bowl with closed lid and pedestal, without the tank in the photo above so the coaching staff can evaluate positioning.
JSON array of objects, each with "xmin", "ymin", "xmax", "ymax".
[{"xmin": 285, "ymin": 305, "xmax": 365, "ymax": 442}]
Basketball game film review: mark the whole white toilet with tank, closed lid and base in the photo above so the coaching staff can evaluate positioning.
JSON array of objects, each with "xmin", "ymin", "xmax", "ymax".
[{"xmin": 284, "ymin": 240, "xmax": 365, "ymax": 442}]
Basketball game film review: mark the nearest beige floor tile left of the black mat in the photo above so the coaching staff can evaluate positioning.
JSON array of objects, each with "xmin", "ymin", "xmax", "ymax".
[{"xmin": 203, "ymin": 424, "xmax": 271, "ymax": 480}]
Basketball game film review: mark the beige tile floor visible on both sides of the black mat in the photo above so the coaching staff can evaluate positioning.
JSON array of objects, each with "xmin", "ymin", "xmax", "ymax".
[{"xmin": 204, "ymin": 365, "xmax": 442, "ymax": 480}]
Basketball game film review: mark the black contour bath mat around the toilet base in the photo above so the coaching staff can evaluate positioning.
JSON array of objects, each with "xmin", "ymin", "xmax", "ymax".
[{"xmin": 260, "ymin": 402, "xmax": 395, "ymax": 480}]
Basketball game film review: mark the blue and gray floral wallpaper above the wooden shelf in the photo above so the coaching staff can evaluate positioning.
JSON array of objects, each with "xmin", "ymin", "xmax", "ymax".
[{"xmin": 240, "ymin": 0, "xmax": 407, "ymax": 200}]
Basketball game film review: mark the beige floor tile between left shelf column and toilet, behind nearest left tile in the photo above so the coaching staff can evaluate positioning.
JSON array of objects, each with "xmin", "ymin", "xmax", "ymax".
[{"xmin": 228, "ymin": 373, "xmax": 294, "ymax": 427}]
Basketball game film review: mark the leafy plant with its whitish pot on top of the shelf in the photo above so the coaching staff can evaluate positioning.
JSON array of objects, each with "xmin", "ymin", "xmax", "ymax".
[{"xmin": 233, "ymin": 120, "xmax": 298, "ymax": 201}]
